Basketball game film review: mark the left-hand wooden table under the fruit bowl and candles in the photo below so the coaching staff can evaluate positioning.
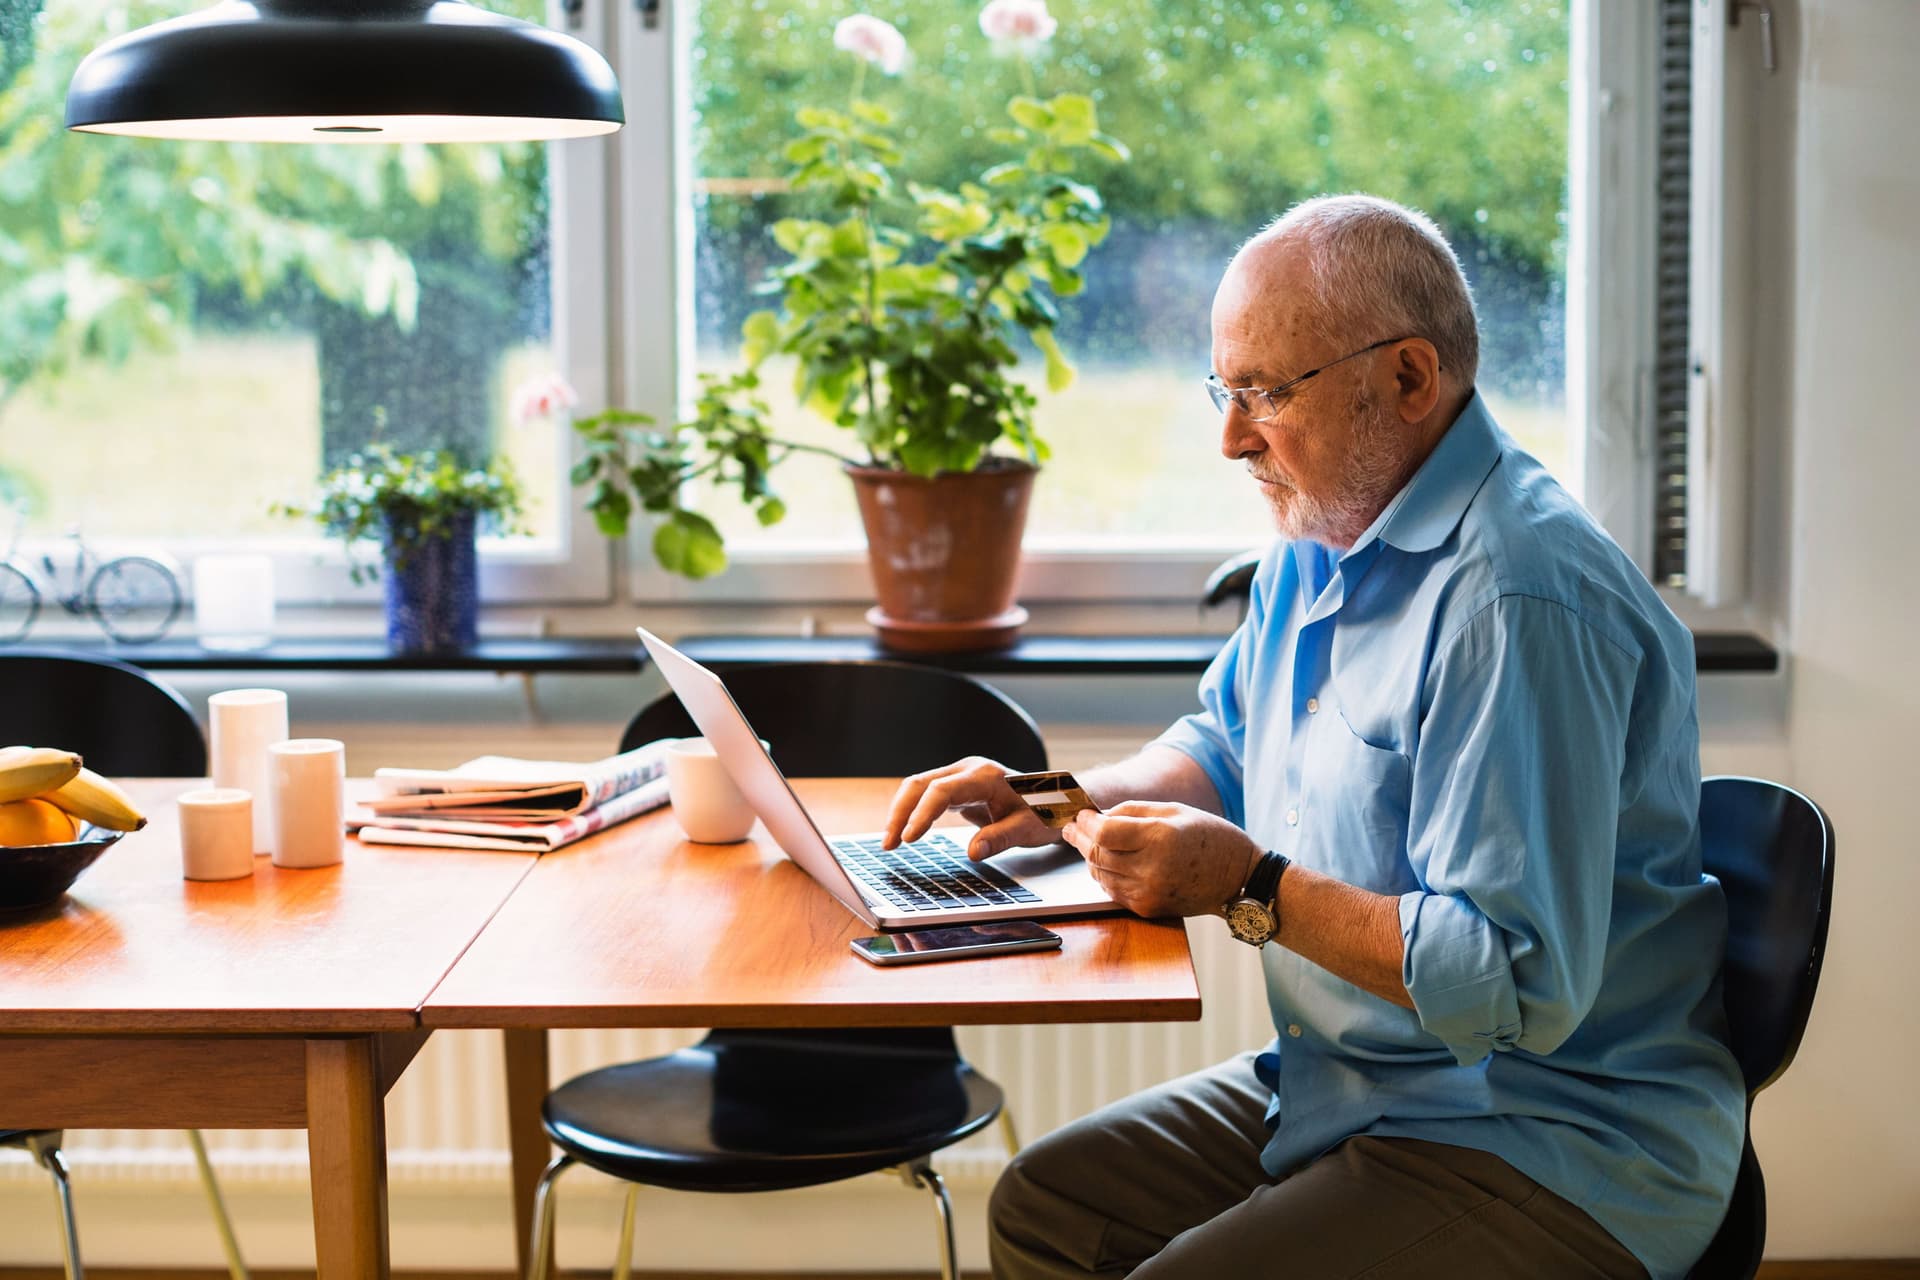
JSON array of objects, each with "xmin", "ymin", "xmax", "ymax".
[{"xmin": 0, "ymin": 779, "xmax": 534, "ymax": 1280}]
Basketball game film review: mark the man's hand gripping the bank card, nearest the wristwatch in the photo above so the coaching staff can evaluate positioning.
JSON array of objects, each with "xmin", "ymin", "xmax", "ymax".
[{"xmin": 1060, "ymin": 800, "xmax": 1261, "ymax": 915}]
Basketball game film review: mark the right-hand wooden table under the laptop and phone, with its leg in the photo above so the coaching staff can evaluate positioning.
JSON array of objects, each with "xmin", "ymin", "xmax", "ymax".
[{"xmin": 420, "ymin": 779, "xmax": 1200, "ymax": 1274}]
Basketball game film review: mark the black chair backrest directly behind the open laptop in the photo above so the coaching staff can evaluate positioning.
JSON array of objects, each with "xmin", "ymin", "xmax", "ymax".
[{"xmin": 620, "ymin": 662, "xmax": 1046, "ymax": 777}]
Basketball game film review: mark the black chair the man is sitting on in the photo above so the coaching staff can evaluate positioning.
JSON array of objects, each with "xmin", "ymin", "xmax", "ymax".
[{"xmin": 1688, "ymin": 777, "xmax": 1834, "ymax": 1280}]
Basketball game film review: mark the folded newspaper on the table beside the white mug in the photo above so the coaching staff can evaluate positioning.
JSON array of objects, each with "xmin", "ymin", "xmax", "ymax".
[{"xmin": 348, "ymin": 743, "xmax": 666, "ymax": 852}]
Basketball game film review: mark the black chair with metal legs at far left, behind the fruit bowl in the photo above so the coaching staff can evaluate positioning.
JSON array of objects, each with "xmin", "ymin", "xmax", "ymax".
[{"xmin": 0, "ymin": 651, "xmax": 248, "ymax": 1280}]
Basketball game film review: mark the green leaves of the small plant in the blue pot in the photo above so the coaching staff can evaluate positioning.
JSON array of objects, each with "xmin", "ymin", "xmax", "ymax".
[{"xmin": 273, "ymin": 441, "xmax": 522, "ymax": 581}]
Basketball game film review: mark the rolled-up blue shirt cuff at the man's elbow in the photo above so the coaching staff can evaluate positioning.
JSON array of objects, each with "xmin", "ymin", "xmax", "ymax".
[{"xmin": 1400, "ymin": 890, "xmax": 1521, "ymax": 1067}]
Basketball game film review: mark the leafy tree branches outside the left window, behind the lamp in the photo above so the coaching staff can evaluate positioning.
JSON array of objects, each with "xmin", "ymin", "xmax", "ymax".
[{"xmin": 0, "ymin": 0, "xmax": 545, "ymax": 416}]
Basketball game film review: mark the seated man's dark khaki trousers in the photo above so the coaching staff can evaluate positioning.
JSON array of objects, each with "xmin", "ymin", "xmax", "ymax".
[{"xmin": 989, "ymin": 1054, "xmax": 1647, "ymax": 1280}]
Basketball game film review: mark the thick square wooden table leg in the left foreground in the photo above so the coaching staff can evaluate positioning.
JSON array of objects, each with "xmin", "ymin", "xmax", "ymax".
[{"xmin": 307, "ymin": 1036, "xmax": 392, "ymax": 1280}]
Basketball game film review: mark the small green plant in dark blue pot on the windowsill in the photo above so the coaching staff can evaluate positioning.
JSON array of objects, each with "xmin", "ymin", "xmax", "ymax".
[{"xmin": 275, "ymin": 441, "xmax": 520, "ymax": 652}]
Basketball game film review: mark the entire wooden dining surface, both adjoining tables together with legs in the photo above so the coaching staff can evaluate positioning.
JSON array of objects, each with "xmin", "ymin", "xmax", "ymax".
[{"xmin": 0, "ymin": 779, "xmax": 1200, "ymax": 1280}]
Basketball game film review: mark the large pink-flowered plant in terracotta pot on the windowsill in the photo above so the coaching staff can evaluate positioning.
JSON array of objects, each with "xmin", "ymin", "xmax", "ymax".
[{"xmin": 530, "ymin": 0, "xmax": 1127, "ymax": 649}]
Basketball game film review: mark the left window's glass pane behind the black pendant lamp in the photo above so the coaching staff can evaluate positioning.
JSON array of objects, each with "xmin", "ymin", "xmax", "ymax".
[{"xmin": 0, "ymin": 0, "xmax": 566, "ymax": 539}]
